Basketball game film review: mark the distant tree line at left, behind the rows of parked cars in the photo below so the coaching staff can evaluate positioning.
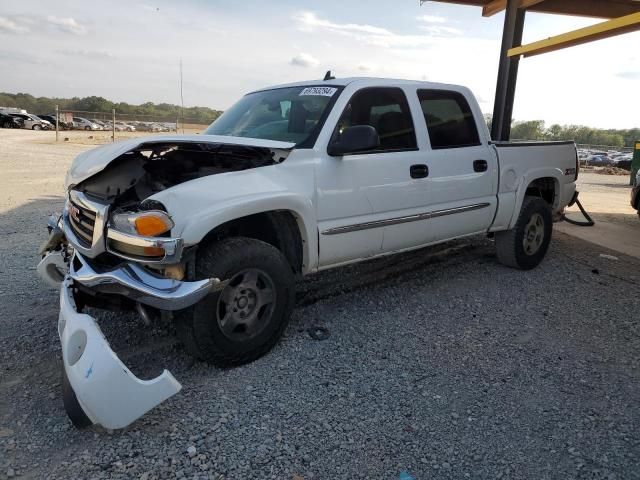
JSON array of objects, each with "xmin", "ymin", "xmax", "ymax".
[{"xmin": 0, "ymin": 93, "xmax": 222, "ymax": 125}]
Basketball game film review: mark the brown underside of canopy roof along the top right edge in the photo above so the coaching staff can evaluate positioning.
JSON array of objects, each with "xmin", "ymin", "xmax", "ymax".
[{"xmin": 431, "ymin": 0, "xmax": 640, "ymax": 18}]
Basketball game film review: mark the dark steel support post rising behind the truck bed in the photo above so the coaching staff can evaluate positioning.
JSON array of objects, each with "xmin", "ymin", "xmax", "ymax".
[{"xmin": 491, "ymin": 0, "xmax": 525, "ymax": 141}]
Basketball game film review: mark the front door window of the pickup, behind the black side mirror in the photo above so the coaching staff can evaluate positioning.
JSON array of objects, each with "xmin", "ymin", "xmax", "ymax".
[{"xmin": 332, "ymin": 87, "xmax": 417, "ymax": 153}]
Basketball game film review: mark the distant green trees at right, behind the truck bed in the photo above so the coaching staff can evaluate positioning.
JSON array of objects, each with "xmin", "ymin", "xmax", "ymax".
[{"xmin": 486, "ymin": 116, "xmax": 640, "ymax": 147}]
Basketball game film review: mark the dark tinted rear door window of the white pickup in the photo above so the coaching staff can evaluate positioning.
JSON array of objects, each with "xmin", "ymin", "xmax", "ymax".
[{"xmin": 418, "ymin": 90, "xmax": 481, "ymax": 150}]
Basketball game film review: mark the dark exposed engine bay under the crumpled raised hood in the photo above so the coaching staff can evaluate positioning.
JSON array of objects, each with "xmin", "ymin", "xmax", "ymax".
[{"xmin": 75, "ymin": 141, "xmax": 288, "ymax": 209}]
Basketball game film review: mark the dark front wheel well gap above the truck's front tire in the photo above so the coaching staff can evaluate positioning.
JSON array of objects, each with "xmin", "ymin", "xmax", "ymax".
[{"xmin": 200, "ymin": 210, "xmax": 303, "ymax": 273}]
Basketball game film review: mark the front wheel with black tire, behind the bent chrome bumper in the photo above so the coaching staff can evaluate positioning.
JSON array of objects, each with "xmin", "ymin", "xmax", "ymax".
[{"xmin": 176, "ymin": 237, "xmax": 295, "ymax": 367}]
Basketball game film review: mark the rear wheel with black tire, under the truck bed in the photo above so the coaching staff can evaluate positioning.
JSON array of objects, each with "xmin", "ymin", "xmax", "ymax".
[{"xmin": 495, "ymin": 197, "xmax": 553, "ymax": 270}]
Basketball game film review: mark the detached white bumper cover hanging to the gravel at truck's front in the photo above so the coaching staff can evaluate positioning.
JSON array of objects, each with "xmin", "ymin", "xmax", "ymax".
[{"xmin": 58, "ymin": 278, "xmax": 182, "ymax": 429}]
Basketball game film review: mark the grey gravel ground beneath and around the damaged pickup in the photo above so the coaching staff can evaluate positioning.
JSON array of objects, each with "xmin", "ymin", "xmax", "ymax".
[{"xmin": 0, "ymin": 131, "xmax": 640, "ymax": 480}]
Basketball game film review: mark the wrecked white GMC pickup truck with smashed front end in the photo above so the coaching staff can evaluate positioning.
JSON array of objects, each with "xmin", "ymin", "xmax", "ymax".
[{"xmin": 38, "ymin": 78, "xmax": 578, "ymax": 428}]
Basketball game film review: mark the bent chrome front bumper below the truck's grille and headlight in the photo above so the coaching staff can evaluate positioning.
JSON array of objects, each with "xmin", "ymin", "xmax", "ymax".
[{"xmin": 69, "ymin": 252, "xmax": 216, "ymax": 310}]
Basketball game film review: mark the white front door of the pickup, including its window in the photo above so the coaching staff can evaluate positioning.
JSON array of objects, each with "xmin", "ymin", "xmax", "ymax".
[{"xmin": 316, "ymin": 87, "xmax": 429, "ymax": 268}]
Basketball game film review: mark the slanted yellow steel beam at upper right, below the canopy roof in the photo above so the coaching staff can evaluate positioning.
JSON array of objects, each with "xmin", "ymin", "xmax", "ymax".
[{"xmin": 507, "ymin": 12, "xmax": 640, "ymax": 57}]
